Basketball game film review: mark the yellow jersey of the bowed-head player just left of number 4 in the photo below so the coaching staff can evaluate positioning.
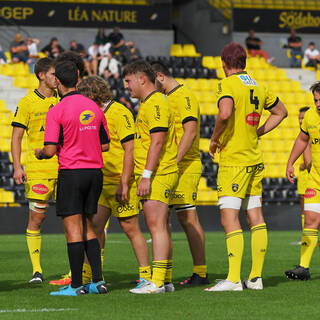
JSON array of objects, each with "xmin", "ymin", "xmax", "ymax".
[{"xmin": 167, "ymin": 85, "xmax": 202, "ymax": 173}]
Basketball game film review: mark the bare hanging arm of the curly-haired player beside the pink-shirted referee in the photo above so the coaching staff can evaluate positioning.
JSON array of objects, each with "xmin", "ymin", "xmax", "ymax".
[{"xmin": 116, "ymin": 140, "xmax": 134, "ymax": 202}]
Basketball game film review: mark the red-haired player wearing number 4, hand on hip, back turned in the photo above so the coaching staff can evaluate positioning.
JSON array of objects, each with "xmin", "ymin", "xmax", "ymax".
[{"xmin": 206, "ymin": 42, "xmax": 287, "ymax": 291}]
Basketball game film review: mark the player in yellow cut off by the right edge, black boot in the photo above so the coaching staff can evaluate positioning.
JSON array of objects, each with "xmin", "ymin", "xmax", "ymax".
[{"xmin": 285, "ymin": 82, "xmax": 320, "ymax": 280}]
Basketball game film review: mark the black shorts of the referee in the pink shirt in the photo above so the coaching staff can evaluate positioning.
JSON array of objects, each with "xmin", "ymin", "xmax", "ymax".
[{"xmin": 56, "ymin": 169, "xmax": 102, "ymax": 216}]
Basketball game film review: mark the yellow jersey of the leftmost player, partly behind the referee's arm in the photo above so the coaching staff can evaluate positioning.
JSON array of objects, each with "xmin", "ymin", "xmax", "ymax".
[{"xmin": 11, "ymin": 89, "xmax": 59, "ymax": 179}]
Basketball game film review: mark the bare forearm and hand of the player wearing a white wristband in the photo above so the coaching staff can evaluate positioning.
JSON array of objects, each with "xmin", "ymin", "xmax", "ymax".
[{"xmin": 137, "ymin": 132, "xmax": 166, "ymax": 197}]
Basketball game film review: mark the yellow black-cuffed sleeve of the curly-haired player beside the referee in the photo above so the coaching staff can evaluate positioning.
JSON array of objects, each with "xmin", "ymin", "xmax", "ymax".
[{"xmin": 115, "ymin": 106, "xmax": 135, "ymax": 143}]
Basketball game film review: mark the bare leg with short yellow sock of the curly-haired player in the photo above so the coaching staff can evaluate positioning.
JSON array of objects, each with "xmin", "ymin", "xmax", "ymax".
[{"xmin": 118, "ymin": 215, "xmax": 151, "ymax": 281}]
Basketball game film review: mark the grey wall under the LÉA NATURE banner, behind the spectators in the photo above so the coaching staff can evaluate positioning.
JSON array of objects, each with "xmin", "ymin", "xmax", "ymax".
[{"xmin": 0, "ymin": 25, "xmax": 173, "ymax": 56}]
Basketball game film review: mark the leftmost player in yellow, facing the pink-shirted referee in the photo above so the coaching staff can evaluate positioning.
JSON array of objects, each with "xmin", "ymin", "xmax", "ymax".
[{"xmin": 11, "ymin": 58, "xmax": 59, "ymax": 283}]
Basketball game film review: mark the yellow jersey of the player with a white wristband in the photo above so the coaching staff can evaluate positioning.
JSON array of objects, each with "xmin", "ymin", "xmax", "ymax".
[{"xmin": 134, "ymin": 91, "xmax": 178, "ymax": 175}]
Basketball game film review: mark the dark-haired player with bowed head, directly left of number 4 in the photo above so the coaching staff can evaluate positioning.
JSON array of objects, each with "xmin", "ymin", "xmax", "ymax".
[{"xmin": 151, "ymin": 62, "xmax": 209, "ymax": 286}]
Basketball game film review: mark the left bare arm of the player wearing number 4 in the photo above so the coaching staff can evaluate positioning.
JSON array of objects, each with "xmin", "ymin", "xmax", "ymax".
[{"xmin": 209, "ymin": 98, "xmax": 233, "ymax": 159}]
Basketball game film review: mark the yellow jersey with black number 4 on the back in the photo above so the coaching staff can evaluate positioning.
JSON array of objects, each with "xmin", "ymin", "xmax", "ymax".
[{"xmin": 217, "ymin": 71, "xmax": 279, "ymax": 166}]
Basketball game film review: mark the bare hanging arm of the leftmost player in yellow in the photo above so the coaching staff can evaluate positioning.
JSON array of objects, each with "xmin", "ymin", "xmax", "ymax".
[{"xmin": 11, "ymin": 127, "xmax": 27, "ymax": 184}]
